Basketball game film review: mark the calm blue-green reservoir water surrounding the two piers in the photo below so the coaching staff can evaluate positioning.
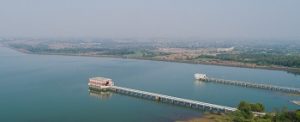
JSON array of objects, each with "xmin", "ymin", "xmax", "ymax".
[{"xmin": 0, "ymin": 47, "xmax": 300, "ymax": 122}]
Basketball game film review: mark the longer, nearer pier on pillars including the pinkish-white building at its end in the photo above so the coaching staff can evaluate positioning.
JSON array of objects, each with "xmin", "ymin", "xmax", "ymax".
[{"xmin": 88, "ymin": 77, "xmax": 265, "ymax": 115}]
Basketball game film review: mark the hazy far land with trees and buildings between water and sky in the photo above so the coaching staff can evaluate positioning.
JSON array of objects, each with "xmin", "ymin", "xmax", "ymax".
[{"xmin": 1, "ymin": 38, "xmax": 300, "ymax": 74}]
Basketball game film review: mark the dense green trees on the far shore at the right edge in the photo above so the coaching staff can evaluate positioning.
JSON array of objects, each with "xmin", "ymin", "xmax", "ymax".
[{"xmin": 198, "ymin": 43, "xmax": 300, "ymax": 68}]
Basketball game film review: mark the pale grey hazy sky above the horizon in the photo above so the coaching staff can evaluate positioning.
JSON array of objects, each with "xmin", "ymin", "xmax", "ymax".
[{"xmin": 0, "ymin": 0, "xmax": 300, "ymax": 39}]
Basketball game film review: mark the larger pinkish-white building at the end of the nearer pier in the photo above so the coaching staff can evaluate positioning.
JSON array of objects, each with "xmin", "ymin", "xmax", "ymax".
[{"xmin": 88, "ymin": 77, "xmax": 114, "ymax": 89}]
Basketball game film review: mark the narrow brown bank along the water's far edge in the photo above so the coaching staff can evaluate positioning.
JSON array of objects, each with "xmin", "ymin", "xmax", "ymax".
[{"xmin": 6, "ymin": 45, "xmax": 300, "ymax": 75}]
